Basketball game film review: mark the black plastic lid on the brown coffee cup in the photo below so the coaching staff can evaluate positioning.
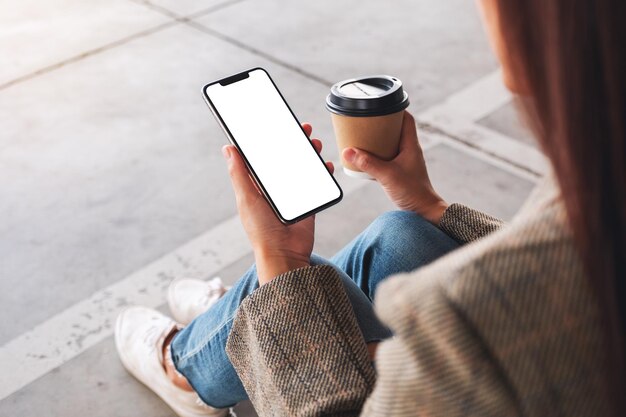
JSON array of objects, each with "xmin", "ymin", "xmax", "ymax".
[{"xmin": 326, "ymin": 75, "xmax": 409, "ymax": 117}]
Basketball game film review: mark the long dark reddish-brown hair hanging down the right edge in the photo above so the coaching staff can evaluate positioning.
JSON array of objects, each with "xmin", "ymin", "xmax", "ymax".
[{"xmin": 497, "ymin": 0, "xmax": 626, "ymax": 415}]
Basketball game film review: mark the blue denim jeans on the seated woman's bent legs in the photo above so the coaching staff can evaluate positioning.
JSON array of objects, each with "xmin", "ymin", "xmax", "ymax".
[{"xmin": 171, "ymin": 211, "xmax": 459, "ymax": 408}]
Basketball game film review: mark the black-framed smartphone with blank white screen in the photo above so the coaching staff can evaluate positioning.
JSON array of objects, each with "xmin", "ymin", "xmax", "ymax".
[{"xmin": 202, "ymin": 68, "xmax": 343, "ymax": 224}]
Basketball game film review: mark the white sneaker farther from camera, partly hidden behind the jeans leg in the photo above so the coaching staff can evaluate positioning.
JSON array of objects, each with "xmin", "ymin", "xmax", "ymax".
[{"xmin": 167, "ymin": 277, "xmax": 228, "ymax": 325}]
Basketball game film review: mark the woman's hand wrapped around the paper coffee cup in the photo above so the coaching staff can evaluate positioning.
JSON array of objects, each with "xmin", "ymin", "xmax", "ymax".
[{"xmin": 342, "ymin": 111, "xmax": 448, "ymax": 224}]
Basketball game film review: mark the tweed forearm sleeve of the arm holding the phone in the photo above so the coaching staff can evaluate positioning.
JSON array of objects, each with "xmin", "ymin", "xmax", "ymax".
[{"xmin": 226, "ymin": 265, "xmax": 375, "ymax": 417}]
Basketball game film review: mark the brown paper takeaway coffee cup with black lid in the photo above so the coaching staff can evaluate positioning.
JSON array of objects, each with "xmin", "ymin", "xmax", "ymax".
[{"xmin": 326, "ymin": 75, "xmax": 409, "ymax": 179}]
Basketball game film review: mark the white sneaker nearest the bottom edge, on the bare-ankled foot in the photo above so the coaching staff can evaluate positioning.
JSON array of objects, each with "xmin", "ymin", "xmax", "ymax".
[{"xmin": 115, "ymin": 307, "xmax": 229, "ymax": 417}]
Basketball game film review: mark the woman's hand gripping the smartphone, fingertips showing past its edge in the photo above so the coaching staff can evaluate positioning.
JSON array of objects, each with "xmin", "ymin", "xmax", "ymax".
[{"xmin": 222, "ymin": 123, "xmax": 334, "ymax": 285}]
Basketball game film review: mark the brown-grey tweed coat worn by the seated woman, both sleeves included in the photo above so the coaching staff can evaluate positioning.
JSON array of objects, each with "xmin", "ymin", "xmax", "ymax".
[{"xmin": 227, "ymin": 178, "xmax": 609, "ymax": 417}]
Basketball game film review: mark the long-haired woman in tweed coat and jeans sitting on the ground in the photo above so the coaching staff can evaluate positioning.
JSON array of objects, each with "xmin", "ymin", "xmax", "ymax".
[{"xmin": 116, "ymin": 0, "xmax": 626, "ymax": 416}]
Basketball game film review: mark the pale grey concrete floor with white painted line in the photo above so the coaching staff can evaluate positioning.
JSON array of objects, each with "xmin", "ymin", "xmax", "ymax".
[{"xmin": 0, "ymin": 0, "xmax": 543, "ymax": 417}]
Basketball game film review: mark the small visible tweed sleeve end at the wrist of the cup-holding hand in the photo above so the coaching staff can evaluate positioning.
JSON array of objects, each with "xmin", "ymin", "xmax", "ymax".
[{"xmin": 439, "ymin": 203, "xmax": 504, "ymax": 243}]
